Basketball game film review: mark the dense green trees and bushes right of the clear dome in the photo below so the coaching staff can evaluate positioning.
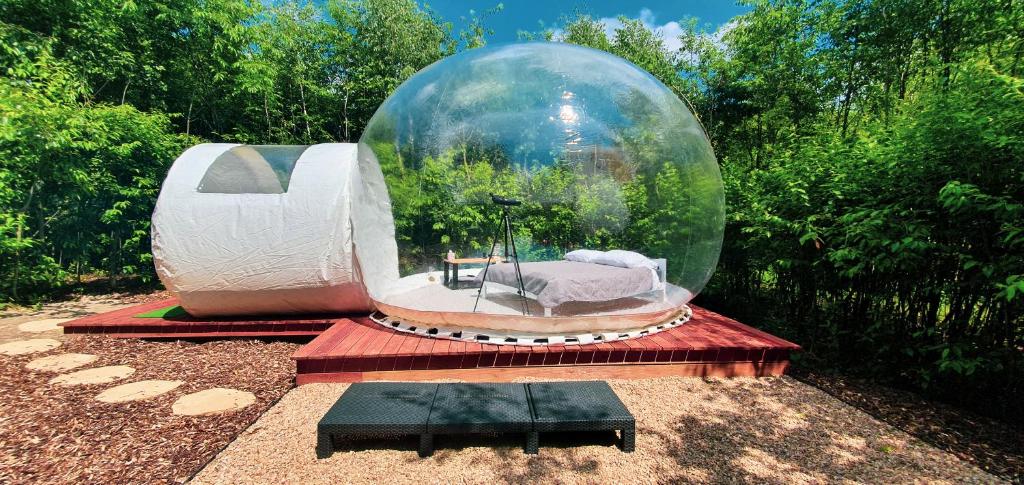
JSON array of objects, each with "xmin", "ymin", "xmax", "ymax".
[{"xmin": 684, "ymin": 1, "xmax": 1024, "ymax": 418}]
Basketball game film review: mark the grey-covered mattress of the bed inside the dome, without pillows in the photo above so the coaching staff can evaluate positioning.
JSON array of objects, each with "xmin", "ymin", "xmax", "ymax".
[{"xmin": 476, "ymin": 261, "xmax": 656, "ymax": 308}]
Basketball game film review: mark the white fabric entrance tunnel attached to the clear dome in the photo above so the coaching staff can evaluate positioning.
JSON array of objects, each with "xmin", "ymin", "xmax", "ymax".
[{"xmin": 153, "ymin": 143, "xmax": 397, "ymax": 316}]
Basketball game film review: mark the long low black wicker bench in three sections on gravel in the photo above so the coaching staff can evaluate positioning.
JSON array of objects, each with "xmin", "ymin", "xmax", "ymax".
[{"xmin": 316, "ymin": 382, "xmax": 636, "ymax": 457}]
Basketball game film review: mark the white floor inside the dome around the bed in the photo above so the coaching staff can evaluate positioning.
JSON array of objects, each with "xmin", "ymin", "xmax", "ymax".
[{"xmin": 384, "ymin": 271, "xmax": 690, "ymax": 316}]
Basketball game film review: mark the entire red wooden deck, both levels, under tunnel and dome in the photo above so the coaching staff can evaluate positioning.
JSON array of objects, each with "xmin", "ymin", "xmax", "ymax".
[{"xmin": 62, "ymin": 299, "xmax": 800, "ymax": 385}]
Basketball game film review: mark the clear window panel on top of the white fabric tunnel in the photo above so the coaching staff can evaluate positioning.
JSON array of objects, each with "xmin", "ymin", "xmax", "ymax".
[{"xmin": 198, "ymin": 145, "xmax": 309, "ymax": 193}]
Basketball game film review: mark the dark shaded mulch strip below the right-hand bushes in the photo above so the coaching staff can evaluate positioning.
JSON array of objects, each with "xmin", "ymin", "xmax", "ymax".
[{"xmin": 796, "ymin": 371, "xmax": 1024, "ymax": 483}]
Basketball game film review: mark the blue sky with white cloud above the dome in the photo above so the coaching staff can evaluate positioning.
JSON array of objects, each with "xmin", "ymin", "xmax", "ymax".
[{"xmin": 421, "ymin": 0, "xmax": 750, "ymax": 48}]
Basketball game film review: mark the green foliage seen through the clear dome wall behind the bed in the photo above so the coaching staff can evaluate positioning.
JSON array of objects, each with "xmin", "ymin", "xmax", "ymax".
[{"xmin": 375, "ymin": 143, "xmax": 701, "ymax": 274}]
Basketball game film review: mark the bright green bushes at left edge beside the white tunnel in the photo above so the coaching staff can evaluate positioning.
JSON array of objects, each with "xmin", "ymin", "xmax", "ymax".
[{"xmin": 0, "ymin": 31, "xmax": 185, "ymax": 299}]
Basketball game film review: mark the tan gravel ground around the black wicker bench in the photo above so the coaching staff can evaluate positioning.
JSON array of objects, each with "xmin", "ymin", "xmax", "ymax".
[{"xmin": 195, "ymin": 378, "xmax": 998, "ymax": 484}]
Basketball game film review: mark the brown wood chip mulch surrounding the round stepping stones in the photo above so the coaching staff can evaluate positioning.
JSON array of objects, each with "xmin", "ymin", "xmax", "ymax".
[{"xmin": 0, "ymin": 336, "xmax": 299, "ymax": 483}]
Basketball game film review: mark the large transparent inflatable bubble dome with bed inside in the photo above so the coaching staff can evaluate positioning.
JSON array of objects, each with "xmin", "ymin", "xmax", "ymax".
[{"xmin": 352, "ymin": 43, "xmax": 724, "ymax": 335}]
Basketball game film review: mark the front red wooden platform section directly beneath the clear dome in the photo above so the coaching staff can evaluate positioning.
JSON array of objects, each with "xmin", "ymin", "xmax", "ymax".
[{"xmin": 292, "ymin": 307, "xmax": 800, "ymax": 385}]
